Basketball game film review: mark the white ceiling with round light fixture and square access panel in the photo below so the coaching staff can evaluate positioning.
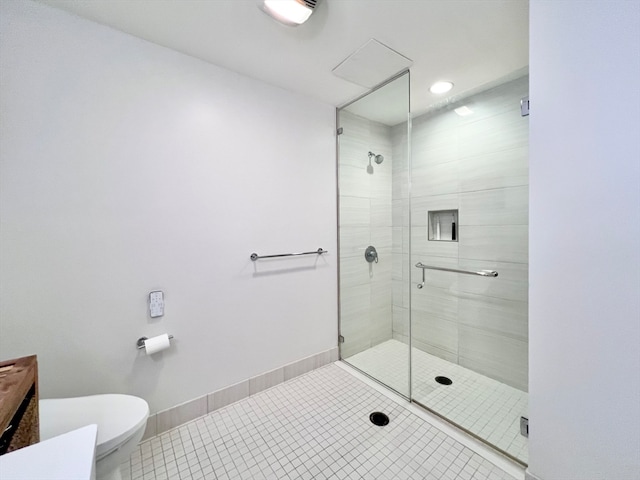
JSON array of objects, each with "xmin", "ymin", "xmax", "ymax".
[{"xmin": 39, "ymin": 0, "xmax": 529, "ymax": 122}]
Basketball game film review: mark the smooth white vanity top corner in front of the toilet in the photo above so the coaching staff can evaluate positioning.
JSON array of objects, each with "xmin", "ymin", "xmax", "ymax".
[{"xmin": 0, "ymin": 425, "xmax": 98, "ymax": 480}]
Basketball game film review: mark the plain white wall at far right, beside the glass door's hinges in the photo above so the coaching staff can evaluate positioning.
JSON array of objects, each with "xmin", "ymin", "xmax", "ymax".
[{"xmin": 529, "ymin": 0, "xmax": 640, "ymax": 480}]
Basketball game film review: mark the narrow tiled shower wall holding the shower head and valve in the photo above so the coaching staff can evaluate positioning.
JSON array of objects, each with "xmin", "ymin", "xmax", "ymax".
[{"xmin": 338, "ymin": 111, "xmax": 397, "ymax": 358}]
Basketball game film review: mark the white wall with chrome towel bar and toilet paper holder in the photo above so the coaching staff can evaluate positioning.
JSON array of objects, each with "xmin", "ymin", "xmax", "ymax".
[{"xmin": 0, "ymin": 1, "xmax": 337, "ymax": 411}]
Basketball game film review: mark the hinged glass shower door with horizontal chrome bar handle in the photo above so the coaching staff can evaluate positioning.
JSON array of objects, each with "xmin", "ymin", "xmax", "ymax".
[{"xmin": 408, "ymin": 76, "xmax": 529, "ymax": 464}]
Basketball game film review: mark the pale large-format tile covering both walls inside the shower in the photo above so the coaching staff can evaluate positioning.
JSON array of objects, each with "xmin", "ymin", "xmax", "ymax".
[{"xmin": 340, "ymin": 78, "xmax": 529, "ymax": 388}]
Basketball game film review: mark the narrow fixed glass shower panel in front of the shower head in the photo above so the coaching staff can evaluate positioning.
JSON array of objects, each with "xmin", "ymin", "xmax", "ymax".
[{"xmin": 337, "ymin": 72, "xmax": 410, "ymax": 398}]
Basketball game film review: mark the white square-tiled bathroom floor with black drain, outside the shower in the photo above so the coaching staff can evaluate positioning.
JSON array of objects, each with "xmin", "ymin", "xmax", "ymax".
[{"xmin": 121, "ymin": 364, "xmax": 514, "ymax": 480}]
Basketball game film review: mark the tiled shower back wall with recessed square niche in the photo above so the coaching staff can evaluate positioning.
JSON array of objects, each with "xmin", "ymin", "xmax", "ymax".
[{"xmin": 393, "ymin": 77, "xmax": 529, "ymax": 390}]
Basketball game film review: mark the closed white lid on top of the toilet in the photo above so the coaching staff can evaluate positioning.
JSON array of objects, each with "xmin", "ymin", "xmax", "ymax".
[{"xmin": 38, "ymin": 394, "xmax": 149, "ymax": 458}]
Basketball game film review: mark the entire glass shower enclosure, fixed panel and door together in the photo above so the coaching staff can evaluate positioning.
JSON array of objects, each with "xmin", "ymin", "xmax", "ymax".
[{"xmin": 337, "ymin": 72, "xmax": 528, "ymax": 464}]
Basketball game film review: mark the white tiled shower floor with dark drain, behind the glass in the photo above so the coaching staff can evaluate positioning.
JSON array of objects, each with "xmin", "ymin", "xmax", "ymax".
[{"xmin": 346, "ymin": 340, "xmax": 529, "ymax": 463}]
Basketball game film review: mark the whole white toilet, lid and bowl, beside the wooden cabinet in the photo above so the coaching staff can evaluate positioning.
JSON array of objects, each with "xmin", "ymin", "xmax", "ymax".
[{"xmin": 38, "ymin": 394, "xmax": 149, "ymax": 480}]
